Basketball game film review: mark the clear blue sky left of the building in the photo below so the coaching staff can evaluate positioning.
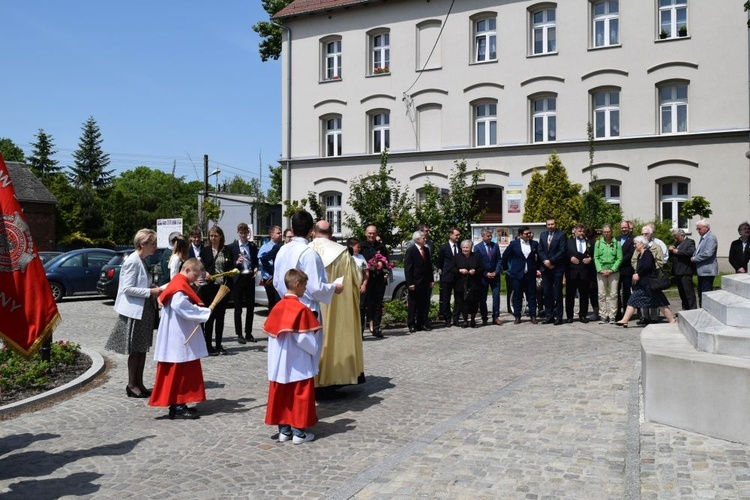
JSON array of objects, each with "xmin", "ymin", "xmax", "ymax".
[{"xmin": 0, "ymin": 0, "xmax": 281, "ymax": 188}]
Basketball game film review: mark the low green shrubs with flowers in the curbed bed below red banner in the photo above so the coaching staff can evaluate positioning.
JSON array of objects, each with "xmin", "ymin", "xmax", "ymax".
[{"xmin": 0, "ymin": 340, "xmax": 81, "ymax": 393}]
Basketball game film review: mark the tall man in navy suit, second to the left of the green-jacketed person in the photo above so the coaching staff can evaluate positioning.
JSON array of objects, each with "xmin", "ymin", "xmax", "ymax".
[{"xmin": 539, "ymin": 219, "xmax": 568, "ymax": 325}]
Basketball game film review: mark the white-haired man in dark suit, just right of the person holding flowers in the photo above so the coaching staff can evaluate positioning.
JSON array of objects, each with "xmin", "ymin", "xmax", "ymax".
[{"xmin": 404, "ymin": 231, "xmax": 433, "ymax": 333}]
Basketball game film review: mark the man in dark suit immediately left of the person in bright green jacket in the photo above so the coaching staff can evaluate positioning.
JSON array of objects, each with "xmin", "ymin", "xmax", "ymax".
[{"xmin": 565, "ymin": 224, "xmax": 596, "ymax": 323}]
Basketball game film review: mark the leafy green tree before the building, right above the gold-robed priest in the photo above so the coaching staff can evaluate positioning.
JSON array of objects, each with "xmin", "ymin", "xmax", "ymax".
[{"xmin": 344, "ymin": 151, "xmax": 412, "ymax": 248}]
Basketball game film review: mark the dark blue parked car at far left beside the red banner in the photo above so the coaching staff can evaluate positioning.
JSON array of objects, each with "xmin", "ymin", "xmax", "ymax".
[{"xmin": 44, "ymin": 248, "xmax": 115, "ymax": 302}]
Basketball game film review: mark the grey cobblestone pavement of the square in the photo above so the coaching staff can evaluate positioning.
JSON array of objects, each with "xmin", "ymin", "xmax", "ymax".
[{"xmin": 0, "ymin": 298, "xmax": 750, "ymax": 499}]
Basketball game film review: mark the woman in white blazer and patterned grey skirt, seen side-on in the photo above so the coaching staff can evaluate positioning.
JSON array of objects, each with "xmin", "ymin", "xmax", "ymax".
[{"xmin": 105, "ymin": 229, "xmax": 161, "ymax": 398}]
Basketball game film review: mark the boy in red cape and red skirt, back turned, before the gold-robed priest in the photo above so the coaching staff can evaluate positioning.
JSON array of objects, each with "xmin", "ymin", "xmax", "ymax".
[{"xmin": 263, "ymin": 269, "xmax": 322, "ymax": 444}]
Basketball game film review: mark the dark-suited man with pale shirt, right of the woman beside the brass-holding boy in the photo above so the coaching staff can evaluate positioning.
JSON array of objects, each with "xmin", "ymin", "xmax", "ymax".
[{"xmin": 229, "ymin": 222, "xmax": 258, "ymax": 344}]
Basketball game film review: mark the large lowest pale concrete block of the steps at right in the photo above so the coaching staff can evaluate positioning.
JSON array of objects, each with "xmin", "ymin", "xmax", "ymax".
[{"xmin": 641, "ymin": 325, "xmax": 750, "ymax": 444}]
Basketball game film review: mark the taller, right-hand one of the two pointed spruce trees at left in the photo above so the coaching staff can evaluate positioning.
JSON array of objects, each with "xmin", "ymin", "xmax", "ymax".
[{"xmin": 70, "ymin": 116, "xmax": 114, "ymax": 191}]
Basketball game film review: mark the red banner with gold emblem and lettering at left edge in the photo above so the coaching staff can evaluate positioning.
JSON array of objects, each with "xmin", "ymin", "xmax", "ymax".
[{"xmin": 0, "ymin": 154, "xmax": 60, "ymax": 357}]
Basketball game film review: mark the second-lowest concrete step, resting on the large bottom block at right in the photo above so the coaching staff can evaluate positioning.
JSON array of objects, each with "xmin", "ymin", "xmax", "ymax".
[{"xmin": 677, "ymin": 309, "xmax": 750, "ymax": 358}]
